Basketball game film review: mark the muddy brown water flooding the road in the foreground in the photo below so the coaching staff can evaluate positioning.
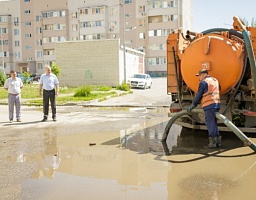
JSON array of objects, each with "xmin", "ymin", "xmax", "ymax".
[{"xmin": 0, "ymin": 106, "xmax": 256, "ymax": 200}]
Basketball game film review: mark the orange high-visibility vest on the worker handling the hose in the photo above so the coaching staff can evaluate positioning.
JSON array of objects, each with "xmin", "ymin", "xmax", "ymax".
[{"xmin": 202, "ymin": 77, "xmax": 220, "ymax": 108}]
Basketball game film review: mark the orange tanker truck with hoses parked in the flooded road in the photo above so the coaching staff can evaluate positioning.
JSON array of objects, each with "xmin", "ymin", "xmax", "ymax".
[{"xmin": 167, "ymin": 17, "xmax": 256, "ymax": 133}]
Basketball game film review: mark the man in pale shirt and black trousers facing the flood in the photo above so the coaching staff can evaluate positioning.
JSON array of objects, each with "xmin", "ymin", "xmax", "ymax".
[{"xmin": 39, "ymin": 65, "xmax": 59, "ymax": 122}]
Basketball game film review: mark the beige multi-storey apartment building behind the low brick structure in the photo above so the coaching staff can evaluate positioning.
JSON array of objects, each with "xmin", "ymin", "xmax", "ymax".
[{"xmin": 0, "ymin": 0, "xmax": 192, "ymax": 76}]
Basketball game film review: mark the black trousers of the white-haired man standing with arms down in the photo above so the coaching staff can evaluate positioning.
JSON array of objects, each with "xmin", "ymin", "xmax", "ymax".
[{"xmin": 43, "ymin": 89, "xmax": 56, "ymax": 119}]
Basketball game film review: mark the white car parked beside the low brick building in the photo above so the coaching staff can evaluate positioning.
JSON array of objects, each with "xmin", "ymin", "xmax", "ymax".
[{"xmin": 127, "ymin": 74, "xmax": 152, "ymax": 89}]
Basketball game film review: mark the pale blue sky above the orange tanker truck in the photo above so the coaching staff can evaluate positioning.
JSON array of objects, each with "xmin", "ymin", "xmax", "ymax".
[{"xmin": 191, "ymin": 0, "xmax": 256, "ymax": 32}]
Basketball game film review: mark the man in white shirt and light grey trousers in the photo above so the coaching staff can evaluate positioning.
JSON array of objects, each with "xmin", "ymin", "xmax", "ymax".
[{"xmin": 4, "ymin": 70, "xmax": 23, "ymax": 123}]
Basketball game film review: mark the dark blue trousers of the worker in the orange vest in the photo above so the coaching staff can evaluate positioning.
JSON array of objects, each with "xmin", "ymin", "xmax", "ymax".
[{"xmin": 204, "ymin": 108, "xmax": 220, "ymax": 137}]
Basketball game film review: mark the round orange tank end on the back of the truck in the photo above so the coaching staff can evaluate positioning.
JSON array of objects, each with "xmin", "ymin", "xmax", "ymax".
[{"xmin": 181, "ymin": 34, "xmax": 244, "ymax": 94}]
